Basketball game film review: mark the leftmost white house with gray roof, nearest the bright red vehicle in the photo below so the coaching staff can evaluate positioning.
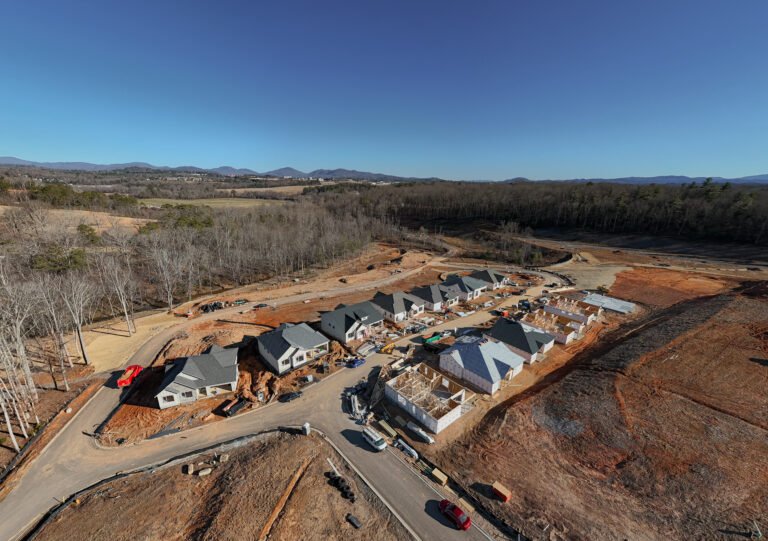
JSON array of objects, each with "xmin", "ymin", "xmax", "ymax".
[{"xmin": 155, "ymin": 346, "xmax": 238, "ymax": 409}]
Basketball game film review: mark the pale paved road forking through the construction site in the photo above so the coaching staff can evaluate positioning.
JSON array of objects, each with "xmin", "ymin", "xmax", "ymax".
[{"xmin": 0, "ymin": 269, "xmax": 556, "ymax": 541}]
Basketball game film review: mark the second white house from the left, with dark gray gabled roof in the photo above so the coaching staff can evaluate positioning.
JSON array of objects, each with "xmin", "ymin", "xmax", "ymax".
[{"xmin": 256, "ymin": 323, "xmax": 329, "ymax": 375}]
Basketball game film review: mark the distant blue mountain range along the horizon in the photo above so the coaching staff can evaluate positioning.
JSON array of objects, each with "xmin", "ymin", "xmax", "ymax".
[{"xmin": 0, "ymin": 156, "xmax": 768, "ymax": 184}]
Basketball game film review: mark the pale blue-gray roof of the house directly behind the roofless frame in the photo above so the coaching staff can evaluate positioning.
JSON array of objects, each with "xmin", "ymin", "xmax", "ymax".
[{"xmin": 441, "ymin": 336, "xmax": 525, "ymax": 383}]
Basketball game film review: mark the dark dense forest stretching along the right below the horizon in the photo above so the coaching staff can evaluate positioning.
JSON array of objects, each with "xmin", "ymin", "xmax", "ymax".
[{"xmin": 307, "ymin": 181, "xmax": 768, "ymax": 245}]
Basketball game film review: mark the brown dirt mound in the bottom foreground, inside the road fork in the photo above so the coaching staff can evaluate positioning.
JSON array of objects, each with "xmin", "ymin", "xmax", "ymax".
[{"xmin": 36, "ymin": 434, "xmax": 409, "ymax": 541}]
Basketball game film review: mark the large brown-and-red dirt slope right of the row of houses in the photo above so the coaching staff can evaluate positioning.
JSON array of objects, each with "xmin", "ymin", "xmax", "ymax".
[{"xmin": 427, "ymin": 280, "xmax": 768, "ymax": 539}]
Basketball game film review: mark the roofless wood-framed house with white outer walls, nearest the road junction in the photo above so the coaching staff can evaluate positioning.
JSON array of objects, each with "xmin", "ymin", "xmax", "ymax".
[{"xmin": 384, "ymin": 364, "xmax": 474, "ymax": 434}]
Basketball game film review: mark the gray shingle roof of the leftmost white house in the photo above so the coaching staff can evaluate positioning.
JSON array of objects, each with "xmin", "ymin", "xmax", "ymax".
[{"xmin": 158, "ymin": 345, "xmax": 238, "ymax": 393}]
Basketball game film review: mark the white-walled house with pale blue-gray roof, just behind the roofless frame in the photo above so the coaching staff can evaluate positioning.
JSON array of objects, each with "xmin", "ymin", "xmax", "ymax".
[{"xmin": 440, "ymin": 336, "xmax": 525, "ymax": 394}]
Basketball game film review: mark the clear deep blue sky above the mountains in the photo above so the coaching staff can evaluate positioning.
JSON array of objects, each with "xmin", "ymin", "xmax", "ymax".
[{"xmin": 0, "ymin": 0, "xmax": 768, "ymax": 179}]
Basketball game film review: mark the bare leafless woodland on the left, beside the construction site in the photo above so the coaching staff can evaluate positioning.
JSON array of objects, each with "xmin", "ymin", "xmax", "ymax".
[{"xmin": 0, "ymin": 201, "xmax": 402, "ymax": 450}]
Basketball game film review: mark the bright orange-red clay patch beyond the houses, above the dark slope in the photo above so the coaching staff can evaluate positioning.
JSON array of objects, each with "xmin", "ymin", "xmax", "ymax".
[{"xmin": 610, "ymin": 267, "xmax": 736, "ymax": 308}]
